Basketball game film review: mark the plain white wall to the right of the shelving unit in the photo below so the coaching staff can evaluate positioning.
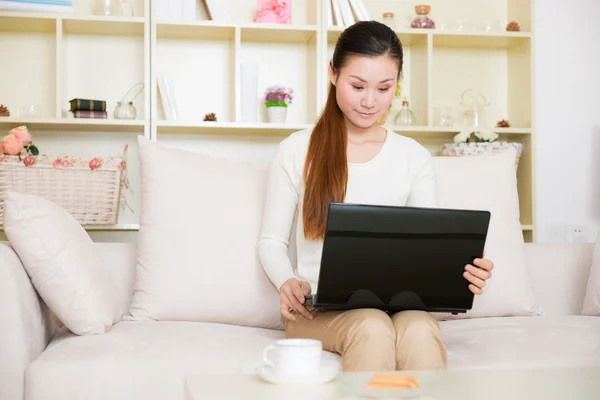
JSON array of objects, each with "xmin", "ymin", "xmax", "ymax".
[{"xmin": 534, "ymin": 0, "xmax": 600, "ymax": 242}]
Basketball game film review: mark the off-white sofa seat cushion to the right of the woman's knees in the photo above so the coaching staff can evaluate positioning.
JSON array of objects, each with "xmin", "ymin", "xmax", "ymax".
[{"xmin": 441, "ymin": 316, "xmax": 600, "ymax": 369}]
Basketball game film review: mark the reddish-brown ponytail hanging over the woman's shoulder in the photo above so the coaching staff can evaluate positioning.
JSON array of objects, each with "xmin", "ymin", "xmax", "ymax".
[{"xmin": 302, "ymin": 80, "xmax": 348, "ymax": 239}]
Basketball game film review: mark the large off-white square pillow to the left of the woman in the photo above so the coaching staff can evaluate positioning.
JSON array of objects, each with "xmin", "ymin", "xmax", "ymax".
[{"xmin": 128, "ymin": 136, "xmax": 282, "ymax": 328}]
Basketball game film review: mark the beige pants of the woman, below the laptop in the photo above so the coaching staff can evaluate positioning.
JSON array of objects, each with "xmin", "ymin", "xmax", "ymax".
[{"xmin": 285, "ymin": 309, "xmax": 446, "ymax": 372}]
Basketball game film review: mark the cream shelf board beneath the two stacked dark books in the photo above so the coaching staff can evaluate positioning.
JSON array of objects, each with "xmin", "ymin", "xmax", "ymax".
[{"xmin": 0, "ymin": 117, "xmax": 145, "ymax": 133}]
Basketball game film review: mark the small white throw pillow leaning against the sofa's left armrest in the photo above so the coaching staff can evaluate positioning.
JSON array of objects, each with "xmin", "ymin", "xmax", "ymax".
[{"xmin": 4, "ymin": 192, "xmax": 122, "ymax": 335}]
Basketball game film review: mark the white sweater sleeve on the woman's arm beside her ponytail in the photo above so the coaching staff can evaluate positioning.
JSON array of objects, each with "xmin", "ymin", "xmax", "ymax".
[{"xmin": 258, "ymin": 141, "xmax": 298, "ymax": 290}]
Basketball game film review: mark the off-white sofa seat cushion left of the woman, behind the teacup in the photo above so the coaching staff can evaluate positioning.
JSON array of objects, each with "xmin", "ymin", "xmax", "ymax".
[{"xmin": 26, "ymin": 321, "xmax": 339, "ymax": 400}]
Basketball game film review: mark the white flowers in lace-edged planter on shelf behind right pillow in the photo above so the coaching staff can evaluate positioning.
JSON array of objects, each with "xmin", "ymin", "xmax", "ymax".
[{"xmin": 441, "ymin": 129, "xmax": 523, "ymax": 166}]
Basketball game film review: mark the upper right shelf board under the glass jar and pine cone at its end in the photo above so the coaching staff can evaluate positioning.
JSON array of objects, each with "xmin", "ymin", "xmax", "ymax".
[{"xmin": 431, "ymin": 32, "xmax": 531, "ymax": 49}]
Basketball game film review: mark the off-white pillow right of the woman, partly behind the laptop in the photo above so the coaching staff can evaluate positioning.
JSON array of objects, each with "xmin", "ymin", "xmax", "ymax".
[{"xmin": 434, "ymin": 153, "xmax": 543, "ymax": 319}]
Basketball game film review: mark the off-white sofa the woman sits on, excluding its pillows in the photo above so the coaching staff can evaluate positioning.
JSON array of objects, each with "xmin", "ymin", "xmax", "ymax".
[{"xmin": 0, "ymin": 239, "xmax": 600, "ymax": 400}]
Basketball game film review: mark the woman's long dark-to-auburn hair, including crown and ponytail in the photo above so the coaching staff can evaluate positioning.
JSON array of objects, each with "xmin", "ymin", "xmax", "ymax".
[{"xmin": 302, "ymin": 21, "xmax": 404, "ymax": 239}]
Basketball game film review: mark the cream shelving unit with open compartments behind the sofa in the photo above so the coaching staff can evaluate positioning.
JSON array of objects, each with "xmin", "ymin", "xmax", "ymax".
[{"xmin": 0, "ymin": 0, "xmax": 536, "ymax": 241}]
